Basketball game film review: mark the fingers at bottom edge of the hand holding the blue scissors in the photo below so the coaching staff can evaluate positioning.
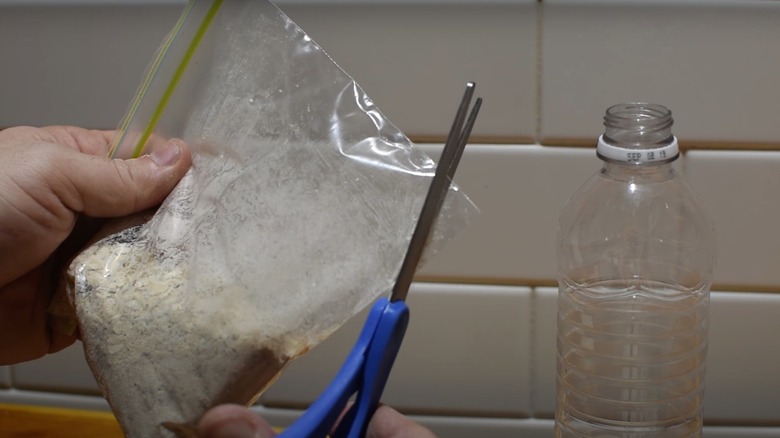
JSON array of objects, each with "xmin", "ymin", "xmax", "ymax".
[{"xmin": 198, "ymin": 405, "xmax": 436, "ymax": 438}]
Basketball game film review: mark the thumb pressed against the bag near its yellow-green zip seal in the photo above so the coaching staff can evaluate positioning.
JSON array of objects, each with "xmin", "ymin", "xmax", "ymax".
[{"xmin": 58, "ymin": 139, "xmax": 191, "ymax": 217}]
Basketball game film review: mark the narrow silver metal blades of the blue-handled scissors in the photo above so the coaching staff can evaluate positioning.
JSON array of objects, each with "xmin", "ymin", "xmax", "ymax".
[{"xmin": 390, "ymin": 82, "xmax": 482, "ymax": 301}]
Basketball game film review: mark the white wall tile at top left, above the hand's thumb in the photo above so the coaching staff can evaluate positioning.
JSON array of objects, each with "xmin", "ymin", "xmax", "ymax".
[{"xmin": 0, "ymin": 2, "xmax": 182, "ymax": 128}]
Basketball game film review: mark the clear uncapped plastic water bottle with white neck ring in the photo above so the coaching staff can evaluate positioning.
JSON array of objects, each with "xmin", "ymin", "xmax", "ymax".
[{"xmin": 555, "ymin": 103, "xmax": 715, "ymax": 438}]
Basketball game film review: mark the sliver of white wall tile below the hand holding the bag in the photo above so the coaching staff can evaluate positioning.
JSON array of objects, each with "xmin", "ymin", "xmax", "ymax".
[{"xmin": 12, "ymin": 342, "xmax": 100, "ymax": 395}]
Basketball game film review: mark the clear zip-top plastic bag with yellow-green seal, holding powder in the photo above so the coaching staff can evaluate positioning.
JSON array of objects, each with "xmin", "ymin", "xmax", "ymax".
[{"xmin": 69, "ymin": 0, "xmax": 475, "ymax": 437}]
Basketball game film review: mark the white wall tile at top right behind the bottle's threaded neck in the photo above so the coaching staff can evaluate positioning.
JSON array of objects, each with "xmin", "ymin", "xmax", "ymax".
[{"xmin": 541, "ymin": 0, "xmax": 780, "ymax": 144}]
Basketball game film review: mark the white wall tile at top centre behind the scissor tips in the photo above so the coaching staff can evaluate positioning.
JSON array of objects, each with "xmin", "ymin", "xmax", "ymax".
[{"xmin": 280, "ymin": 0, "xmax": 537, "ymax": 139}]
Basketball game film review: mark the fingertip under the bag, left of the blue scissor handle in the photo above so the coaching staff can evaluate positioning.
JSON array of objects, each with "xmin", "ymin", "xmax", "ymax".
[{"xmin": 198, "ymin": 405, "xmax": 276, "ymax": 438}]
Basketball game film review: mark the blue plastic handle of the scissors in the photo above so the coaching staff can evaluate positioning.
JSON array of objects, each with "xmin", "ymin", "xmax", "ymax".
[{"xmin": 279, "ymin": 298, "xmax": 409, "ymax": 438}]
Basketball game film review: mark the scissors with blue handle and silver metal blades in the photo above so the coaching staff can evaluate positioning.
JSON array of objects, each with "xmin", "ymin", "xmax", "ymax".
[{"xmin": 279, "ymin": 82, "xmax": 482, "ymax": 438}]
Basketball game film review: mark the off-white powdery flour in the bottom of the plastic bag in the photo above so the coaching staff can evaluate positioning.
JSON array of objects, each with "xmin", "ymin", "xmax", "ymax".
[{"xmin": 73, "ymin": 227, "xmax": 292, "ymax": 437}]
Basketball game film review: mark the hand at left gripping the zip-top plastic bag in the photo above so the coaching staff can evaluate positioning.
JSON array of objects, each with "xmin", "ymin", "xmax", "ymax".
[{"xmin": 0, "ymin": 126, "xmax": 190, "ymax": 365}]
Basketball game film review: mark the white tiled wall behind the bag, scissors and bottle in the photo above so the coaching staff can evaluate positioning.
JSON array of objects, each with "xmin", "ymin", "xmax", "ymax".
[{"xmin": 0, "ymin": 0, "xmax": 780, "ymax": 438}]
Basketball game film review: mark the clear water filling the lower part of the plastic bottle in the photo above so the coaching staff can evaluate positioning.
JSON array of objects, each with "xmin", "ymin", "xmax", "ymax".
[{"xmin": 556, "ymin": 279, "xmax": 708, "ymax": 438}]
